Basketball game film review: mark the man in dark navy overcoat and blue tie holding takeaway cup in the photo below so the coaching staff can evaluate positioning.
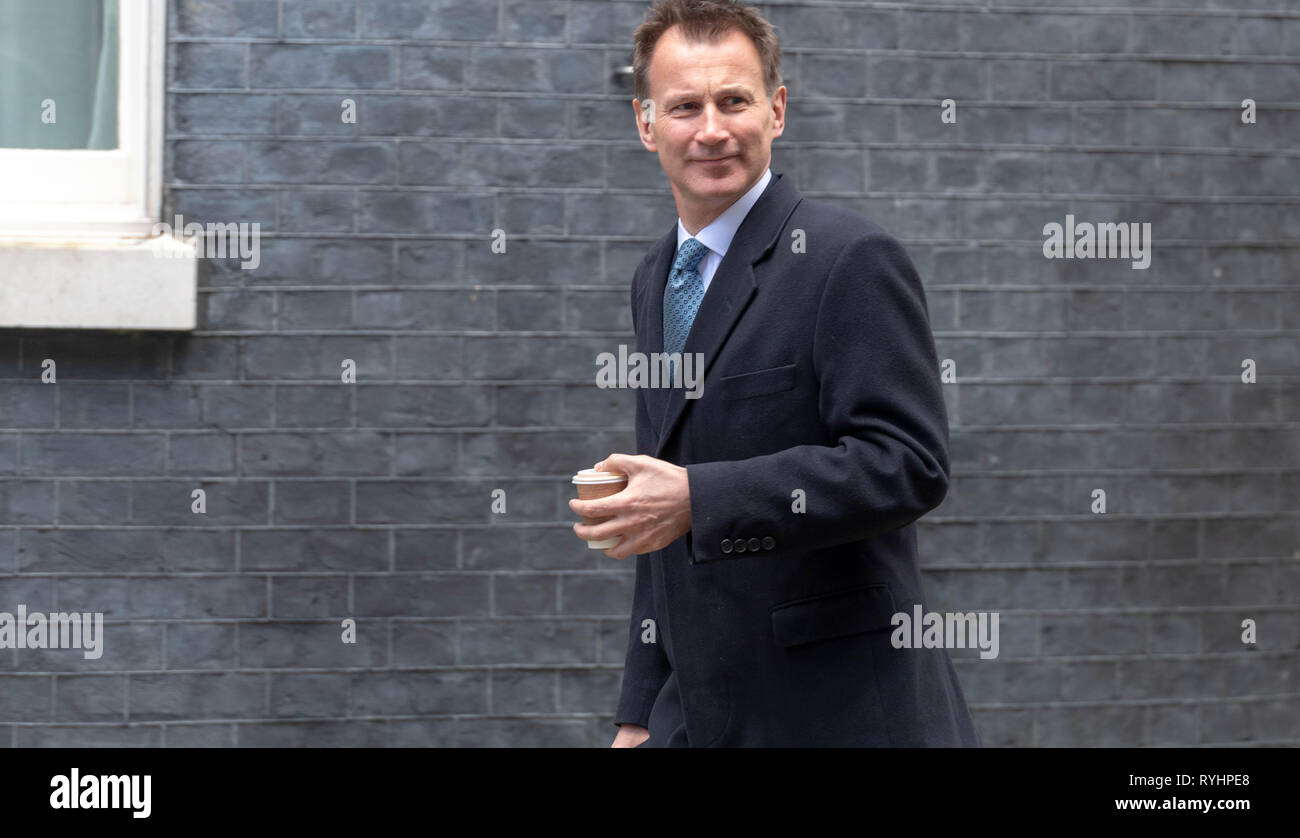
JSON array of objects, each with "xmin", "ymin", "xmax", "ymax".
[{"xmin": 569, "ymin": 0, "xmax": 980, "ymax": 747}]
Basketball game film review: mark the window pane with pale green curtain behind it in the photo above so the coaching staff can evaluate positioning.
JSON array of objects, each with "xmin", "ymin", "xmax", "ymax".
[{"xmin": 0, "ymin": 0, "xmax": 118, "ymax": 149}]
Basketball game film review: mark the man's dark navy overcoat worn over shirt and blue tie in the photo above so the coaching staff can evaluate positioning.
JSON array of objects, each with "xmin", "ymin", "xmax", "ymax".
[{"xmin": 615, "ymin": 171, "xmax": 980, "ymax": 747}]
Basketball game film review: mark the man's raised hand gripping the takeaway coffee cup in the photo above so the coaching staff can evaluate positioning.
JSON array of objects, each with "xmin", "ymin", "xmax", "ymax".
[{"xmin": 569, "ymin": 453, "xmax": 690, "ymax": 559}]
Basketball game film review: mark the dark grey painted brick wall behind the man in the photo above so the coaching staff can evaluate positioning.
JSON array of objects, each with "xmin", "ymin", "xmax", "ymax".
[{"xmin": 0, "ymin": 0, "xmax": 1300, "ymax": 746}]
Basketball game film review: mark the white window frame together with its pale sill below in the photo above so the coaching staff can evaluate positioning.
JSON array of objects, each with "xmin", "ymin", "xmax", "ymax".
[{"xmin": 0, "ymin": 0, "xmax": 198, "ymax": 330}]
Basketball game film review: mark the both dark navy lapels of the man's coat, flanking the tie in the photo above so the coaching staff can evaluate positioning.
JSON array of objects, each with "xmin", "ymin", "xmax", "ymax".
[{"xmin": 637, "ymin": 171, "xmax": 802, "ymax": 457}]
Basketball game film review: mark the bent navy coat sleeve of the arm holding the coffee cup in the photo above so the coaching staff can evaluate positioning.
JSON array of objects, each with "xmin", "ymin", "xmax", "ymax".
[{"xmin": 686, "ymin": 234, "xmax": 948, "ymax": 563}]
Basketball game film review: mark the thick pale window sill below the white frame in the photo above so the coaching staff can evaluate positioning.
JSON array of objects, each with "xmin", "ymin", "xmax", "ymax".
[{"xmin": 0, "ymin": 235, "xmax": 199, "ymax": 331}]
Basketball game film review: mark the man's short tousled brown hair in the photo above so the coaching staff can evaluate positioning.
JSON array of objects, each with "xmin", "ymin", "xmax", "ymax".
[{"xmin": 632, "ymin": 0, "xmax": 781, "ymax": 101}]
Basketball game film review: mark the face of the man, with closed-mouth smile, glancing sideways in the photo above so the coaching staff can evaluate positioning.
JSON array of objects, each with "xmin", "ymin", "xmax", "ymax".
[{"xmin": 632, "ymin": 26, "xmax": 785, "ymax": 216}]
